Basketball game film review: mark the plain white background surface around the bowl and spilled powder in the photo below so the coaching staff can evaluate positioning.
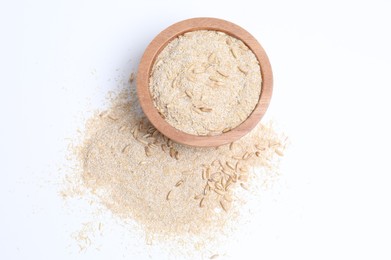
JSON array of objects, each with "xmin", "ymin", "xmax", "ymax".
[{"xmin": 0, "ymin": 0, "xmax": 391, "ymax": 259}]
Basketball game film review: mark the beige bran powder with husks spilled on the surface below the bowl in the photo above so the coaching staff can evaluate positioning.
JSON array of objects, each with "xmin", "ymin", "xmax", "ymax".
[{"xmin": 63, "ymin": 76, "xmax": 284, "ymax": 242}]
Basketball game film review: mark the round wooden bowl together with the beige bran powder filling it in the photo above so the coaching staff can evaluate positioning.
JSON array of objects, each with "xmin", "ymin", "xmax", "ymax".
[{"xmin": 137, "ymin": 18, "xmax": 273, "ymax": 147}]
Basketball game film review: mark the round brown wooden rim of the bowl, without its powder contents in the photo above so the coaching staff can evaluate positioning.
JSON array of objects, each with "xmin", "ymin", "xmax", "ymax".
[{"xmin": 137, "ymin": 18, "xmax": 273, "ymax": 147}]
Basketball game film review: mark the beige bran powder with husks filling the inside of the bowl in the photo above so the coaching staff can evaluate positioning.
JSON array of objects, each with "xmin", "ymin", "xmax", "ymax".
[{"xmin": 149, "ymin": 30, "xmax": 262, "ymax": 135}]
